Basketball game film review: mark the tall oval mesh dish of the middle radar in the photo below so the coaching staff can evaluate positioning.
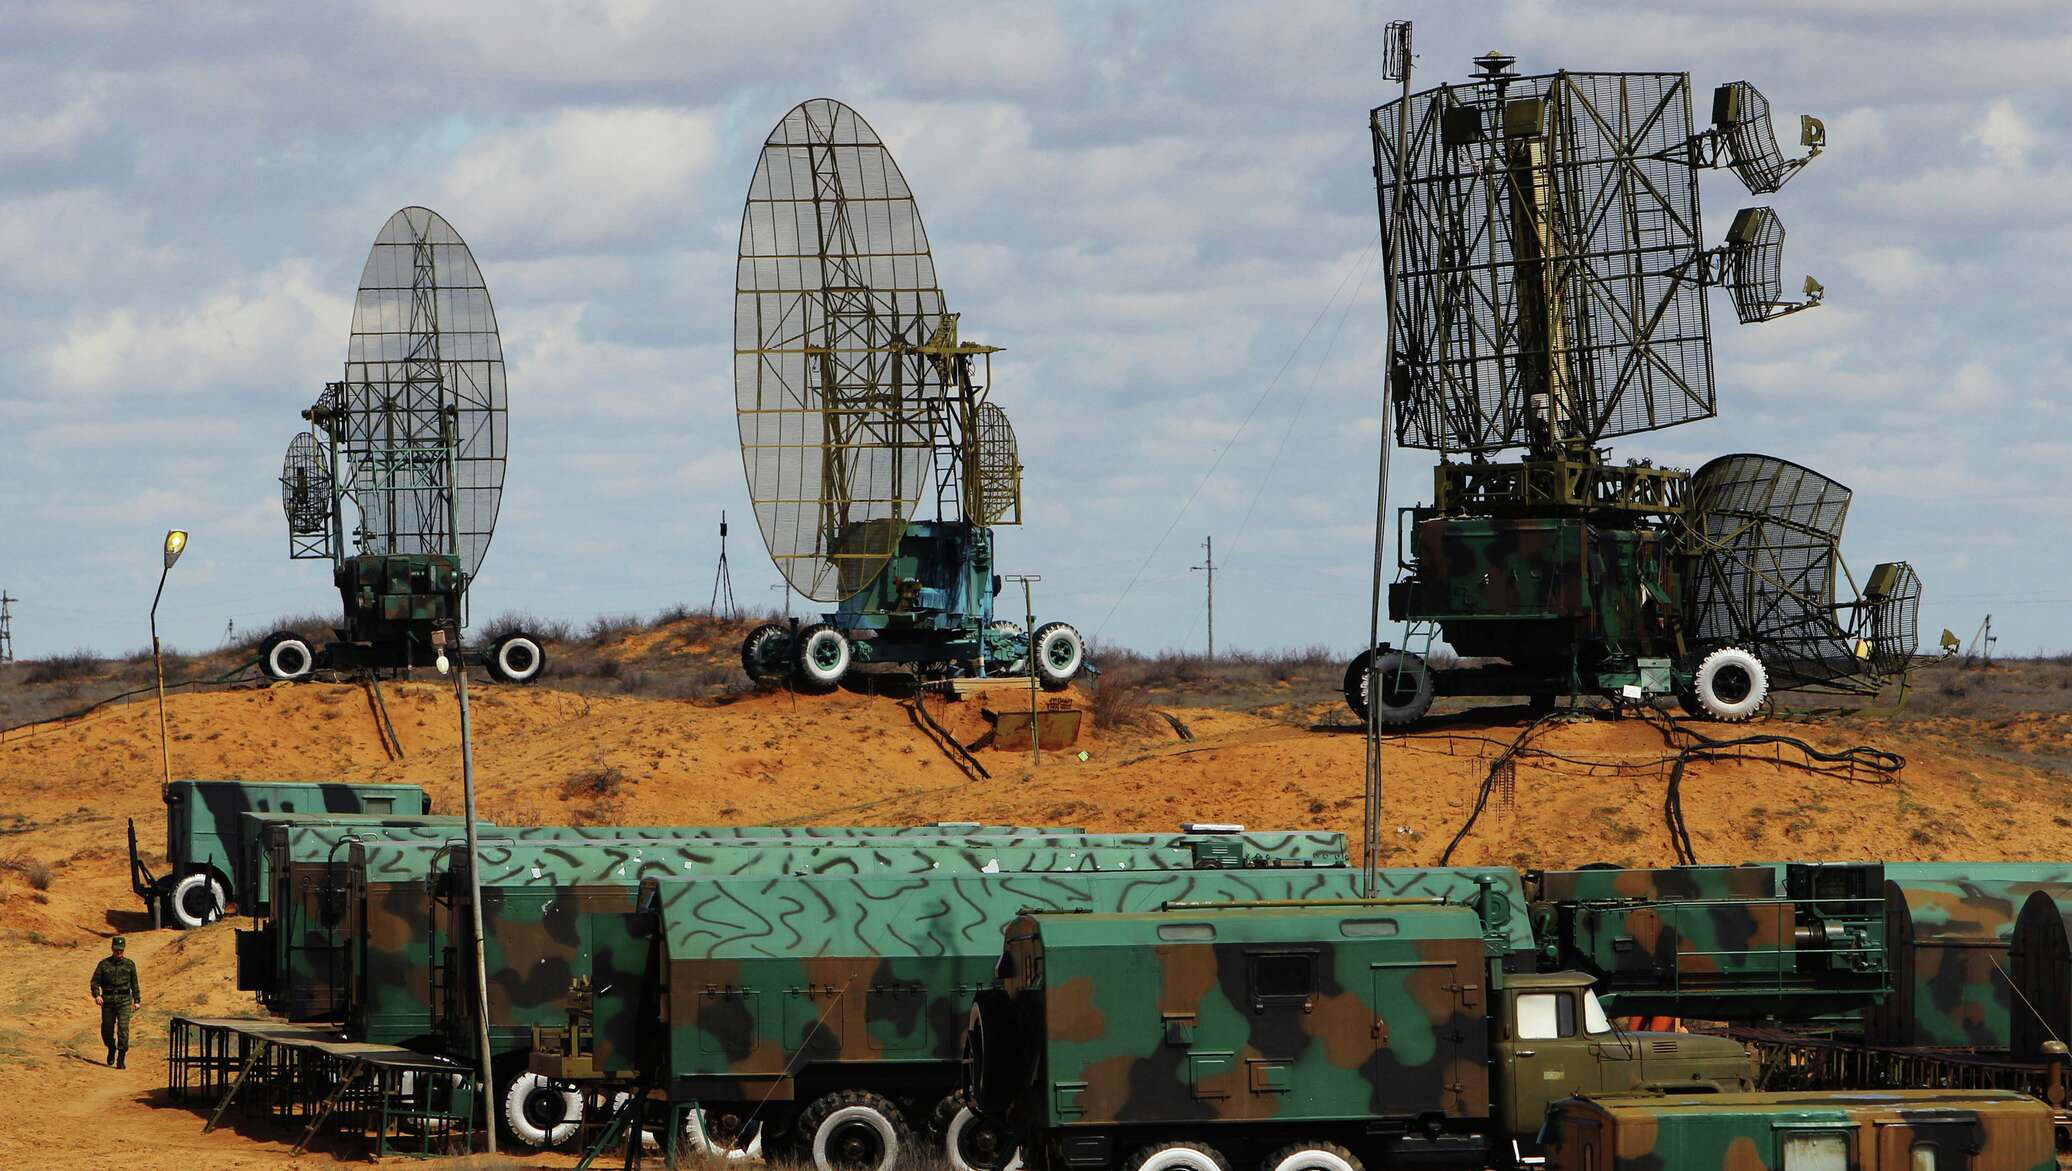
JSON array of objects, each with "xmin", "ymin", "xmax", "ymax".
[{"xmin": 733, "ymin": 97, "xmax": 945, "ymax": 601}]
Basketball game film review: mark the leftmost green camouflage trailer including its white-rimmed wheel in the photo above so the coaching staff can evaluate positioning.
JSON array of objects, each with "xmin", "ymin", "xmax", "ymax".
[{"xmin": 128, "ymin": 781, "xmax": 431, "ymax": 926}]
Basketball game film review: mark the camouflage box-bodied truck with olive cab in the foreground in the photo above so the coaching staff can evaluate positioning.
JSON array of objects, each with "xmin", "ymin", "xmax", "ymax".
[{"xmin": 968, "ymin": 899, "xmax": 1755, "ymax": 1171}]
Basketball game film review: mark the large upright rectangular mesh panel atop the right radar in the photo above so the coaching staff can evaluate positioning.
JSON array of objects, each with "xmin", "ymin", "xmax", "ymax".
[{"xmin": 1372, "ymin": 73, "xmax": 1714, "ymax": 452}]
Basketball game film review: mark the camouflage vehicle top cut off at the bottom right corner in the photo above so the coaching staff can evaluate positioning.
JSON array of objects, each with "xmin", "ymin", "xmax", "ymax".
[{"xmin": 1542, "ymin": 1090, "xmax": 2057, "ymax": 1171}]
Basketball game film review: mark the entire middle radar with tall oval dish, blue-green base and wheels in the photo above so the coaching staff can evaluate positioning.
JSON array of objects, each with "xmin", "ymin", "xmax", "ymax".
[{"xmin": 733, "ymin": 97, "xmax": 1084, "ymax": 688}]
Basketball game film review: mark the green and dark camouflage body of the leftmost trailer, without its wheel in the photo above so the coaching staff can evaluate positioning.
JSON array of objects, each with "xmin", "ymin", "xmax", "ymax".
[{"xmin": 145, "ymin": 781, "xmax": 431, "ymax": 902}]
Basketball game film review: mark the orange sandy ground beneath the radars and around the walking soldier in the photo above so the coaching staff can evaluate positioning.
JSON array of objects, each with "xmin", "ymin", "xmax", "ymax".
[{"xmin": 0, "ymin": 684, "xmax": 2072, "ymax": 1171}]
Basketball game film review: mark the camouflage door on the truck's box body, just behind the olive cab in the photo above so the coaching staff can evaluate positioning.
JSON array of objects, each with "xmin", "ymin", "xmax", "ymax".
[{"xmin": 1370, "ymin": 945, "xmax": 1490, "ymax": 1117}]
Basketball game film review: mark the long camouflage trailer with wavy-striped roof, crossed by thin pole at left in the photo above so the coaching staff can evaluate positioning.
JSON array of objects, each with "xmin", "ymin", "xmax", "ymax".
[{"xmin": 346, "ymin": 833, "xmax": 1345, "ymax": 1144}]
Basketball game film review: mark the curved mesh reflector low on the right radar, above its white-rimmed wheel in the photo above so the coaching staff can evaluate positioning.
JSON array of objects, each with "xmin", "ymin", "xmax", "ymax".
[{"xmin": 1687, "ymin": 456, "xmax": 1871, "ymax": 686}]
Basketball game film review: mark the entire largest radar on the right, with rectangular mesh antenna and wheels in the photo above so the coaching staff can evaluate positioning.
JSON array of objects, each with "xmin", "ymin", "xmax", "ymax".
[{"xmin": 1345, "ymin": 52, "xmax": 1919, "ymax": 723}]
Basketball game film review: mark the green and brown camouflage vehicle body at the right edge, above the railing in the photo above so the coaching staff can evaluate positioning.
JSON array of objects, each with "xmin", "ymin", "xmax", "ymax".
[{"xmin": 1863, "ymin": 864, "xmax": 2072, "ymax": 1053}]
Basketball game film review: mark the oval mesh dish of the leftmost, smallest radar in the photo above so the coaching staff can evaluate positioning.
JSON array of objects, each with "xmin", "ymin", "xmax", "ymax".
[{"xmin": 331, "ymin": 207, "xmax": 510, "ymax": 578}]
